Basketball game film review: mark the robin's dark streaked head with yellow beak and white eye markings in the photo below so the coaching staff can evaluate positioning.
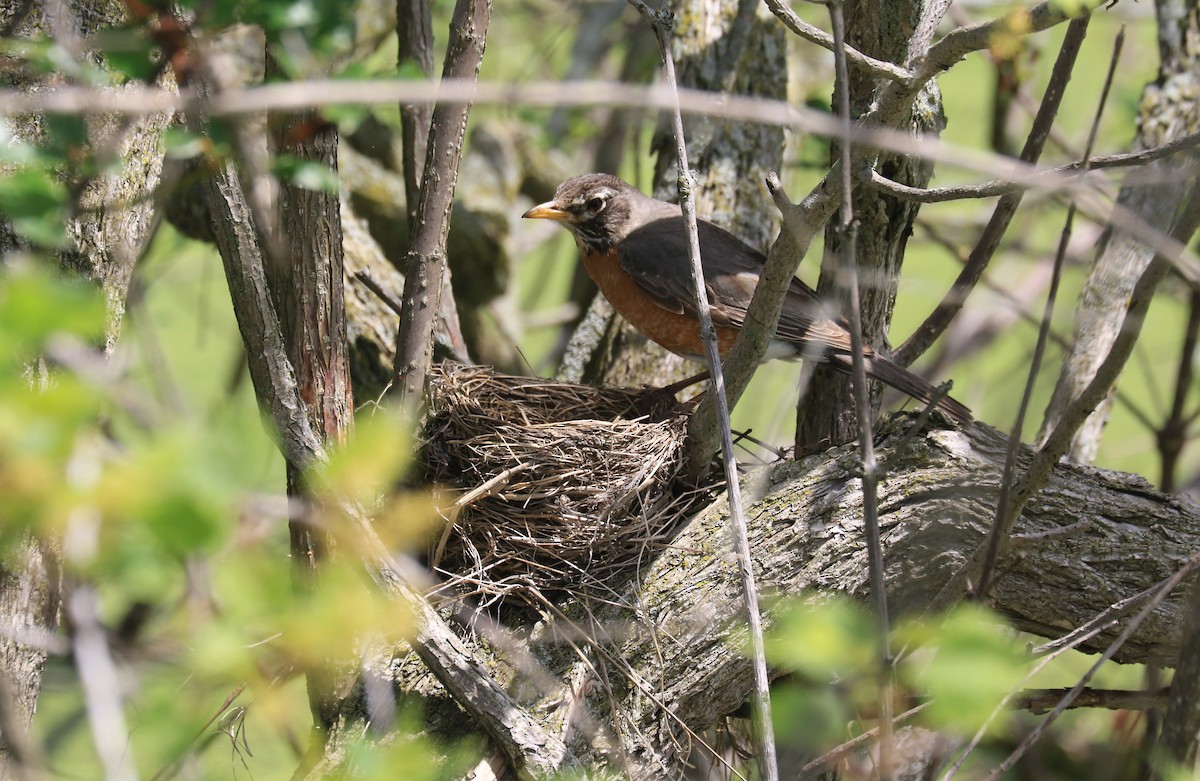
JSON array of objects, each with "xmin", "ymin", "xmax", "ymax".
[{"xmin": 521, "ymin": 174, "xmax": 643, "ymax": 252}]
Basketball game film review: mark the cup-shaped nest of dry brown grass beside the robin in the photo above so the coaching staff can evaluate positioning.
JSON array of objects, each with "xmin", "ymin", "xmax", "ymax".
[{"xmin": 422, "ymin": 364, "xmax": 686, "ymax": 601}]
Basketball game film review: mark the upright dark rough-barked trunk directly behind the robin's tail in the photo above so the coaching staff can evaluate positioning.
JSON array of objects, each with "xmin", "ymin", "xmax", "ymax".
[{"xmin": 796, "ymin": 0, "xmax": 946, "ymax": 452}]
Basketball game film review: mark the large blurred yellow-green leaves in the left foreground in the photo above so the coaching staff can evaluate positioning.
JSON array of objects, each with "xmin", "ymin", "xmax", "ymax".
[{"xmin": 0, "ymin": 245, "xmax": 451, "ymax": 779}]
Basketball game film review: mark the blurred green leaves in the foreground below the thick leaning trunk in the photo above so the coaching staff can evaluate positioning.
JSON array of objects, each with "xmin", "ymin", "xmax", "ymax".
[{"xmin": 766, "ymin": 595, "xmax": 1176, "ymax": 777}]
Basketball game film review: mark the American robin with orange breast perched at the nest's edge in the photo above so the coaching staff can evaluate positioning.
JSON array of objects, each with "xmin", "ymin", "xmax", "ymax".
[{"xmin": 522, "ymin": 174, "xmax": 971, "ymax": 423}]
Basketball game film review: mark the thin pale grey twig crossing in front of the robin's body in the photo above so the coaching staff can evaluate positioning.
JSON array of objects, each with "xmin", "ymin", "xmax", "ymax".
[{"xmin": 630, "ymin": 0, "xmax": 779, "ymax": 781}]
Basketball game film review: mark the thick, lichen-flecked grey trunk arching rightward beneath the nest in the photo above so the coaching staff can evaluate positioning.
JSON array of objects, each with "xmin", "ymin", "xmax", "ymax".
[{"xmin": 384, "ymin": 415, "xmax": 1200, "ymax": 779}]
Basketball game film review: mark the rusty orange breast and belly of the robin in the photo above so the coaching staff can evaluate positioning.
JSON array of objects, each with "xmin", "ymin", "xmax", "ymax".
[{"xmin": 582, "ymin": 253, "xmax": 738, "ymax": 361}]
